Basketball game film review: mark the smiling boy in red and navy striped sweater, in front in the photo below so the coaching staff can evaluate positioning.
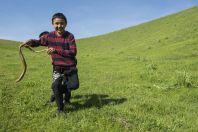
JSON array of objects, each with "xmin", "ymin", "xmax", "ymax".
[{"xmin": 25, "ymin": 13, "xmax": 79, "ymax": 113}]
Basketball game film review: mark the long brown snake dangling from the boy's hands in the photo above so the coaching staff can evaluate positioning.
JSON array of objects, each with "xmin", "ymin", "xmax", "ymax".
[{"xmin": 16, "ymin": 43, "xmax": 48, "ymax": 82}]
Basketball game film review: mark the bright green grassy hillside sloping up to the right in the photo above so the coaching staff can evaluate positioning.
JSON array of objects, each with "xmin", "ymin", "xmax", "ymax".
[{"xmin": 0, "ymin": 7, "xmax": 198, "ymax": 131}]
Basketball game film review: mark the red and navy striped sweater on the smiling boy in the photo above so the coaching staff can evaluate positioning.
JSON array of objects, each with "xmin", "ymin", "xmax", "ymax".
[{"xmin": 29, "ymin": 31, "xmax": 77, "ymax": 67}]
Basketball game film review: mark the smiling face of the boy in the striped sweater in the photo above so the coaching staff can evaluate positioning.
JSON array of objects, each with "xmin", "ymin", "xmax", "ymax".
[{"xmin": 53, "ymin": 18, "xmax": 66, "ymax": 35}]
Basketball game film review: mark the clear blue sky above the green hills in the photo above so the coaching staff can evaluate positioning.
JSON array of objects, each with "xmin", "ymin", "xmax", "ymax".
[{"xmin": 0, "ymin": 0, "xmax": 198, "ymax": 41}]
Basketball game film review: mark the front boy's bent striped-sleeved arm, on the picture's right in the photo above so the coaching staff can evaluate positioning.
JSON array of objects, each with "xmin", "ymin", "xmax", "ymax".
[{"xmin": 56, "ymin": 35, "xmax": 77, "ymax": 57}]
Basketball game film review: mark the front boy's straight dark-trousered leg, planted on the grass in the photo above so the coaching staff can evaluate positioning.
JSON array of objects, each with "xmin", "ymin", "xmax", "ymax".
[{"xmin": 52, "ymin": 71, "xmax": 64, "ymax": 112}]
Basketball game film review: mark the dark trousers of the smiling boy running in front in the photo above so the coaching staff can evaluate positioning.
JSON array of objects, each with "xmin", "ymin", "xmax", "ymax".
[{"xmin": 52, "ymin": 66, "xmax": 79, "ymax": 110}]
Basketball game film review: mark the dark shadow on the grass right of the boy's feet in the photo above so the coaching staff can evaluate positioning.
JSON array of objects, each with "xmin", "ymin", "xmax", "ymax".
[{"xmin": 66, "ymin": 94, "xmax": 127, "ymax": 111}]
